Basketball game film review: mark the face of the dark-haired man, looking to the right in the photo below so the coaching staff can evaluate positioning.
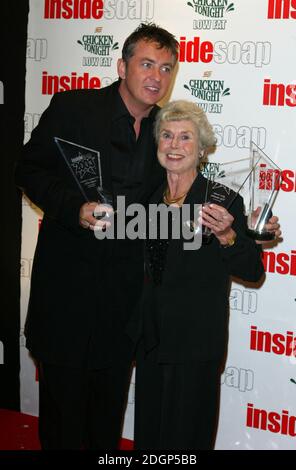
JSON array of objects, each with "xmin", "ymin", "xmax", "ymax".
[{"xmin": 118, "ymin": 40, "xmax": 174, "ymax": 108}]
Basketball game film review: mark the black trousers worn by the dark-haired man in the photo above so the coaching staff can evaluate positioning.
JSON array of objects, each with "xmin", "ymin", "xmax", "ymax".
[{"xmin": 39, "ymin": 361, "xmax": 131, "ymax": 450}]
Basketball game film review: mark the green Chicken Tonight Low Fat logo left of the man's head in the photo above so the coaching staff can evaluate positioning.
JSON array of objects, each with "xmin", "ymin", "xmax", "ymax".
[{"xmin": 77, "ymin": 27, "xmax": 119, "ymax": 67}]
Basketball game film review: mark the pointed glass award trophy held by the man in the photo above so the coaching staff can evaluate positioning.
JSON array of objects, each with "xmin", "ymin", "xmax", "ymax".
[{"xmin": 54, "ymin": 137, "xmax": 113, "ymax": 207}]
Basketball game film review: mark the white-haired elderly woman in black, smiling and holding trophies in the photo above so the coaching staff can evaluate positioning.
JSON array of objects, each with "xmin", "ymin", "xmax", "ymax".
[{"xmin": 129, "ymin": 101, "xmax": 263, "ymax": 449}]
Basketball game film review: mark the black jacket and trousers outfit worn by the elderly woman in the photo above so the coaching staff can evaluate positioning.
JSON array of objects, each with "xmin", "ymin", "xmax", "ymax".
[{"xmin": 129, "ymin": 174, "xmax": 263, "ymax": 450}]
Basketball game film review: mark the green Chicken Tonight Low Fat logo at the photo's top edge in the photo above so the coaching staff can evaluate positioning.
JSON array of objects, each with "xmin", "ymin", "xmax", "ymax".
[{"xmin": 187, "ymin": 0, "xmax": 234, "ymax": 29}]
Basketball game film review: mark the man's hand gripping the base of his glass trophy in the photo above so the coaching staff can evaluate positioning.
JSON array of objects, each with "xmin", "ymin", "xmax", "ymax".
[{"xmin": 79, "ymin": 202, "xmax": 114, "ymax": 230}]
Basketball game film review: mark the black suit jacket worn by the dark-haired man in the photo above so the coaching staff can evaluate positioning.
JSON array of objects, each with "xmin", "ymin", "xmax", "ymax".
[{"xmin": 16, "ymin": 83, "xmax": 163, "ymax": 367}]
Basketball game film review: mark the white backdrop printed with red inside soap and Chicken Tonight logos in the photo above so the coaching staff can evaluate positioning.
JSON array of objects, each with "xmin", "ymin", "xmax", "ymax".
[{"xmin": 20, "ymin": 0, "xmax": 296, "ymax": 450}]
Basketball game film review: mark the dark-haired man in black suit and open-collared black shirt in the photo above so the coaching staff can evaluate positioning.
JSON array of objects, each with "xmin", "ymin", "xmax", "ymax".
[{"xmin": 16, "ymin": 24, "xmax": 178, "ymax": 449}]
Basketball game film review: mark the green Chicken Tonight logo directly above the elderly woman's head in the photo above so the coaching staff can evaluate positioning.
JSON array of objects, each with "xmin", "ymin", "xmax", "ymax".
[{"xmin": 184, "ymin": 72, "xmax": 230, "ymax": 114}]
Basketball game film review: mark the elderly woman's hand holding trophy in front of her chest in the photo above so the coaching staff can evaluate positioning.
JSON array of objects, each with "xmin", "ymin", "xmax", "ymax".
[{"xmin": 199, "ymin": 204, "xmax": 235, "ymax": 245}]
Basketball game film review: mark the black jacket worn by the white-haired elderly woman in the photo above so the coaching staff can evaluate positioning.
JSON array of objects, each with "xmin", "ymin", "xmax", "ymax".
[{"xmin": 127, "ymin": 174, "xmax": 264, "ymax": 363}]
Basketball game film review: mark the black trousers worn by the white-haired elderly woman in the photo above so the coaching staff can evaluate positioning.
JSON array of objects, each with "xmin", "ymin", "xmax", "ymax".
[{"xmin": 135, "ymin": 346, "xmax": 220, "ymax": 450}]
